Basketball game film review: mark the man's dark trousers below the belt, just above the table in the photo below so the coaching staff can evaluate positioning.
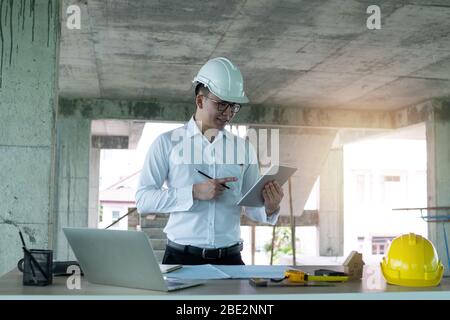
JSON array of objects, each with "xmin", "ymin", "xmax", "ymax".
[{"xmin": 162, "ymin": 246, "xmax": 245, "ymax": 265}]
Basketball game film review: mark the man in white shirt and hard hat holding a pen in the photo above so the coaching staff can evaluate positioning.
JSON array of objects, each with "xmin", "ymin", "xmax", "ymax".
[{"xmin": 136, "ymin": 58, "xmax": 283, "ymax": 265}]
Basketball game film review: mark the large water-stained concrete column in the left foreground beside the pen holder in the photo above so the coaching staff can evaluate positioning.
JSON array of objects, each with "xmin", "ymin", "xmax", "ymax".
[{"xmin": 0, "ymin": 0, "xmax": 60, "ymax": 275}]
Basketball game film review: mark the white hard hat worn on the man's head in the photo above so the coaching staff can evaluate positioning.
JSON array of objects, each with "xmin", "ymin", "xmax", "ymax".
[{"xmin": 193, "ymin": 57, "xmax": 248, "ymax": 103}]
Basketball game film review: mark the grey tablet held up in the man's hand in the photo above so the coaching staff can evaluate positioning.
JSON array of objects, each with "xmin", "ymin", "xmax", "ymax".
[{"xmin": 237, "ymin": 165, "xmax": 297, "ymax": 207}]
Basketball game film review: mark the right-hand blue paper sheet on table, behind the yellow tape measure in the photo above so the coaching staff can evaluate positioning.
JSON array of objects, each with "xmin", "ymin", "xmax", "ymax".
[{"xmin": 216, "ymin": 265, "xmax": 289, "ymax": 279}]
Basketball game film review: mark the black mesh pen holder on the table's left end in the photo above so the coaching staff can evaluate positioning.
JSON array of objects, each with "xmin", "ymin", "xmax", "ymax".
[{"xmin": 17, "ymin": 249, "xmax": 53, "ymax": 286}]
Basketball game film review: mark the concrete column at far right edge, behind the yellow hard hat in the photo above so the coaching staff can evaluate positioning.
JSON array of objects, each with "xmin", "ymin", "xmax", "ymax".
[{"xmin": 426, "ymin": 100, "xmax": 450, "ymax": 276}]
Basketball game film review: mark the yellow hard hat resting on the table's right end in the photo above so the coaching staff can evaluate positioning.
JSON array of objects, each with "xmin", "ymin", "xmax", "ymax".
[{"xmin": 381, "ymin": 233, "xmax": 444, "ymax": 287}]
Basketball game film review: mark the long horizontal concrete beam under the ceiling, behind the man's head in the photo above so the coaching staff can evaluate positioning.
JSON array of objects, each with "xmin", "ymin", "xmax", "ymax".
[{"xmin": 59, "ymin": 98, "xmax": 394, "ymax": 130}]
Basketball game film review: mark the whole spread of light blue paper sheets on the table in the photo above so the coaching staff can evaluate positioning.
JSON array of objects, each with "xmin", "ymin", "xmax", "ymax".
[{"xmin": 168, "ymin": 264, "xmax": 289, "ymax": 280}]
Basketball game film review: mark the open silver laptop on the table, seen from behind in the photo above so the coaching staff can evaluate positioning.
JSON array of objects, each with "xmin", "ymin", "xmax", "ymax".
[{"xmin": 63, "ymin": 228, "xmax": 203, "ymax": 291}]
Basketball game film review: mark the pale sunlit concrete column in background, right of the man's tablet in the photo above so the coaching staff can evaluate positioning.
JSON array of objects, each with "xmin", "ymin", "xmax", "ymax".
[{"xmin": 319, "ymin": 148, "xmax": 344, "ymax": 256}]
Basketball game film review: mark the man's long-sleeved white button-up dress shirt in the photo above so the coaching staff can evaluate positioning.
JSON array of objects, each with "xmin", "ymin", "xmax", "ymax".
[{"xmin": 136, "ymin": 118, "xmax": 278, "ymax": 248}]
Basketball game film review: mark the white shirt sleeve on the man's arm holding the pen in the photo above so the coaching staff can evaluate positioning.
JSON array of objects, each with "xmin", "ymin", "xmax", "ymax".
[{"xmin": 136, "ymin": 135, "xmax": 194, "ymax": 214}]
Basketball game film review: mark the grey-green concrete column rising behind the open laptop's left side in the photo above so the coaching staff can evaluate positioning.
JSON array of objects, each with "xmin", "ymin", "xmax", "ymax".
[{"xmin": 54, "ymin": 116, "xmax": 91, "ymax": 260}]
